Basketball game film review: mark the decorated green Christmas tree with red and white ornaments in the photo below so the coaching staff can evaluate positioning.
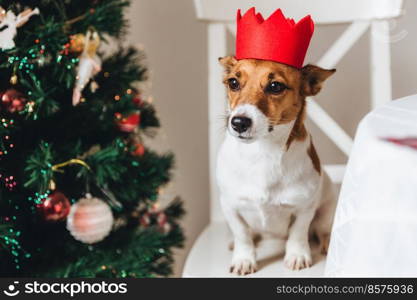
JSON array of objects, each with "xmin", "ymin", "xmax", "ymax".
[{"xmin": 0, "ymin": 0, "xmax": 183, "ymax": 277}]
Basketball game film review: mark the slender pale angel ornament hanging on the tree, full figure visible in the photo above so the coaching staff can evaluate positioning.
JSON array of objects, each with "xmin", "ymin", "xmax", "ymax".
[{"xmin": 72, "ymin": 30, "xmax": 101, "ymax": 106}]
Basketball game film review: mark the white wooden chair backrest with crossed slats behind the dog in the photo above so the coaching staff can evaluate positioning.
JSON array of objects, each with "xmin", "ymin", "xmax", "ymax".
[{"xmin": 194, "ymin": 0, "xmax": 403, "ymax": 221}]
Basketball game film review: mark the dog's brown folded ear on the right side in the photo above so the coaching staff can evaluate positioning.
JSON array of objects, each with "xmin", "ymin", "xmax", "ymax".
[{"xmin": 301, "ymin": 65, "xmax": 336, "ymax": 96}]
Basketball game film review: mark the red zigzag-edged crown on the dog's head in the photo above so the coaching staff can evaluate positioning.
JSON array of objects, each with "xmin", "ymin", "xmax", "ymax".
[{"xmin": 236, "ymin": 7, "xmax": 314, "ymax": 68}]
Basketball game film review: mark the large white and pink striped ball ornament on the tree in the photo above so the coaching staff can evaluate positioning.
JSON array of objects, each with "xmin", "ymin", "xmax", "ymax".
[{"xmin": 67, "ymin": 194, "xmax": 113, "ymax": 244}]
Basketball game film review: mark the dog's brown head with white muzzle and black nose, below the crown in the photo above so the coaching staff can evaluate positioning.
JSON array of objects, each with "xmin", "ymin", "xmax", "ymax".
[{"xmin": 219, "ymin": 56, "xmax": 335, "ymax": 142}]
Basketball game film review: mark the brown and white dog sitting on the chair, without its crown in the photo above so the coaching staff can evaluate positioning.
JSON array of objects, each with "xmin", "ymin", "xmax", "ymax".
[{"xmin": 216, "ymin": 56, "xmax": 336, "ymax": 275}]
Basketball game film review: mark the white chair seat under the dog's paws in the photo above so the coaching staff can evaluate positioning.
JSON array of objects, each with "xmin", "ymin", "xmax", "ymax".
[{"xmin": 183, "ymin": 222, "xmax": 326, "ymax": 278}]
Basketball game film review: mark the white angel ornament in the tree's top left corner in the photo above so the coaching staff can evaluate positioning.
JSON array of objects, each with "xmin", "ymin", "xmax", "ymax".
[{"xmin": 0, "ymin": 7, "xmax": 39, "ymax": 50}]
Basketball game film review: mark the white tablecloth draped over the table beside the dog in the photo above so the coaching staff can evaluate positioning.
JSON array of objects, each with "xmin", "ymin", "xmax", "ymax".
[{"xmin": 325, "ymin": 95, "xmax": 417, "ymax": 277}]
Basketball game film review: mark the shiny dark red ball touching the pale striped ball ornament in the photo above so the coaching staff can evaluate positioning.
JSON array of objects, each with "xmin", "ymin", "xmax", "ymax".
[{"xmin": 37, "ymin": 191, "xmax": 71, "ymax": 222}]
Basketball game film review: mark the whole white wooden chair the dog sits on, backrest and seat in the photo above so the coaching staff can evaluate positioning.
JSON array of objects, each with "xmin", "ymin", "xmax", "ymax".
[{"xmin": 183, "ymin": 0, "xmax": 403, "ymax": 277}]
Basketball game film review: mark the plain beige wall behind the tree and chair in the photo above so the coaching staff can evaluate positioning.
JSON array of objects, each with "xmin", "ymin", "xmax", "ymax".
[{"xmin": 127, "ymin": 0, "xmax": 417, "ymax": 275}]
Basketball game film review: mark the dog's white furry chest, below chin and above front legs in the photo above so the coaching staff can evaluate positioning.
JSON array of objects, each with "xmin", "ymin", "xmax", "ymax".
[{"xmin": 217, "ymin": 137, "xmax": 321, "ymax": 236}]
